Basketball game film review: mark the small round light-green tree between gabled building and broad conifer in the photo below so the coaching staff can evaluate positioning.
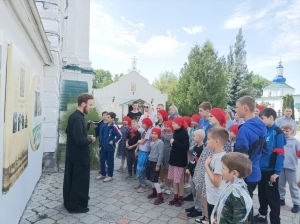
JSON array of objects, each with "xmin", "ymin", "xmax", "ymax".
[{"xmin": 152, "ymin": 71, "xmax": 178, "ymax": 108}]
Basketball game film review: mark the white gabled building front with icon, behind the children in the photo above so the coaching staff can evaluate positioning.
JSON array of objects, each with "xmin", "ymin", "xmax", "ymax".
[{"xmin": 94, "ymin": 71, "xmax": 168, "ymax": 121}]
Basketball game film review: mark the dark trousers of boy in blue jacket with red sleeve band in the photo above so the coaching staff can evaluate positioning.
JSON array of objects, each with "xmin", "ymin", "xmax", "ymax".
[{"xmin": 258, "ymin": 171, "xmax": 280, "ymax": 224}]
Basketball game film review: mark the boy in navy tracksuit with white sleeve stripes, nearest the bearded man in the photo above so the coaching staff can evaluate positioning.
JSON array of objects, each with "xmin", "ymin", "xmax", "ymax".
[{"xmin": 99, "ymin": 112, "xmax": 122, "ymax": 182}]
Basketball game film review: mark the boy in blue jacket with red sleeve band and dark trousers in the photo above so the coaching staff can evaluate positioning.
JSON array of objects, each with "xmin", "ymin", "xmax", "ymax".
[{"xmin": 254, "ymin": 108, "xmax": 286, "ymax": 224}]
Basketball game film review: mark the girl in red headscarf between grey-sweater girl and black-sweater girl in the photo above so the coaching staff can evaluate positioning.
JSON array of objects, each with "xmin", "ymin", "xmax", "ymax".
[{"xmin": 160, "ymin": 121, "xmax": 174, "ymax": 194}]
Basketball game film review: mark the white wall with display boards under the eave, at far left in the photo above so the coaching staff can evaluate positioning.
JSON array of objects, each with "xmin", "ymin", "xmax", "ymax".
[{"xmin": 0, "ymin": 0, "xmax": 53, "ymax": 224}]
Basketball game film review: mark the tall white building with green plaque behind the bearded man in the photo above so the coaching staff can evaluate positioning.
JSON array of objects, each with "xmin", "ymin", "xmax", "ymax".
[{"xmin": 36, "ymin": 0, "xmax": 94, "ymax": 169}]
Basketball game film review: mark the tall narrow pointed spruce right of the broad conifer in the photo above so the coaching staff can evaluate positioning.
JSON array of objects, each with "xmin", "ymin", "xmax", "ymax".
[{"xmin": 227, "ymin": 28, "xmax": 253, "ymax": 107}]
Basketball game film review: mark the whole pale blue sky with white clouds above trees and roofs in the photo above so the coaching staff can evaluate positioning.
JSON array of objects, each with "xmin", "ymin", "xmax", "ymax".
[{"xmin": 90, "ymin": 0, "xmax": 300, "ymax": 93}]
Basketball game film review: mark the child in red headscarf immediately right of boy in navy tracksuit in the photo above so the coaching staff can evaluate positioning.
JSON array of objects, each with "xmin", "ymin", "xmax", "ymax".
[{"xmin": 117, "ymin": 116, "xmax": 131, "ymax": 172}]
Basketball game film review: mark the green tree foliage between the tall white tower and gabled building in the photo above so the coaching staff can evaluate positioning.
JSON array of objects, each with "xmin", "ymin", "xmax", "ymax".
[{"xmin": 93, "ymin": 69, "xmax": 123, "ymax": 89}]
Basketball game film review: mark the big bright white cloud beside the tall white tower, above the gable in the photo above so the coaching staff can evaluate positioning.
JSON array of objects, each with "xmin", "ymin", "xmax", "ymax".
[{"xmin": 90, "ymin": 2, "xmax": 184, "ymax": 57}]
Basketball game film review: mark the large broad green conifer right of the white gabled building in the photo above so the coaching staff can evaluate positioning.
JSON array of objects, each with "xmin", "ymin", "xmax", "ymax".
[{"xmin": 171, "ymin": 41, "xmax": 228, "ymax": 116}]
